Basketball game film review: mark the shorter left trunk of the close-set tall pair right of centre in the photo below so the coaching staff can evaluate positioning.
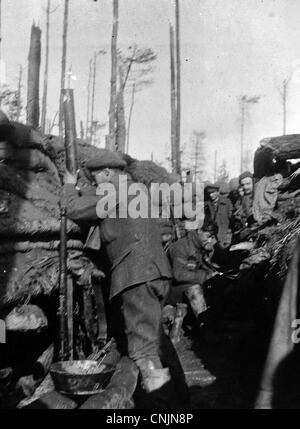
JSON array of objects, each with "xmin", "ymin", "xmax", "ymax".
[{"xmin": 170, "ymin": 24, "xmax": 177, "ymax": 173}]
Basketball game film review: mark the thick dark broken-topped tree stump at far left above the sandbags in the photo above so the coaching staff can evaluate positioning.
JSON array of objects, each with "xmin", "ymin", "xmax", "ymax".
[{"xmin": 27, "ymin": 24, "xmax": 41, "ymax": 128}]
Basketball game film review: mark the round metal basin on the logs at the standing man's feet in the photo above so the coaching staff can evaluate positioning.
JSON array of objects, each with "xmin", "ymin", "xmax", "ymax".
[{"xmin": 50, "ymin": 360, "xmax": 115, "ymax": 395}]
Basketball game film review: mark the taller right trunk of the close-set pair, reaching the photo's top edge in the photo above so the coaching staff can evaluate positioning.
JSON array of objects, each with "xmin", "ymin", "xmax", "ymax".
[{"xmin": 175, "ymin": 0, "xmax": 181, "ymax": 177}]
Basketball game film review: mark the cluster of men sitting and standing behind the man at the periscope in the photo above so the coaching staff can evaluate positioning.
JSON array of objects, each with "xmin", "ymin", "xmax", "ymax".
[{"xmin": 164, "ymin": 171, "xmax": 254, "ymax": 343}]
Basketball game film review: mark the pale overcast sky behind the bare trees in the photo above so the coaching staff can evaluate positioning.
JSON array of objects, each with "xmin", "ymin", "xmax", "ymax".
[{"xmin": 2, "ymin": 0, "xmax": 300, "ymax": 177}]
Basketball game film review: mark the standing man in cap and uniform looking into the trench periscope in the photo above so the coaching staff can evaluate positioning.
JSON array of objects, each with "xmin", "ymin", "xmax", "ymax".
[{"xmin": 63, "ymin": 149, "xmax": 188, "ymax": 406}]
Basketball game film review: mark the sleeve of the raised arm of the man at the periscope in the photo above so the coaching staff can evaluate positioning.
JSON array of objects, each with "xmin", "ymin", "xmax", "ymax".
[{"xmin": 61, "ymin": 184, "xmax": 99, "ymax": 221}]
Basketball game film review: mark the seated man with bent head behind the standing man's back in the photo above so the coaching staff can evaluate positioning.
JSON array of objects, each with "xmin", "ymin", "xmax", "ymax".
[{"xmin": 169, "ymin": 219, "xmax": 218, "ymax": 343}]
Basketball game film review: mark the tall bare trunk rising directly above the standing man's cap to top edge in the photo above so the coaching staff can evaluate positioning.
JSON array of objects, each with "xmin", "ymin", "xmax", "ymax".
[{"xmin": 106, "ymin": 0, "xmax": 119, "ymax": 150}]
